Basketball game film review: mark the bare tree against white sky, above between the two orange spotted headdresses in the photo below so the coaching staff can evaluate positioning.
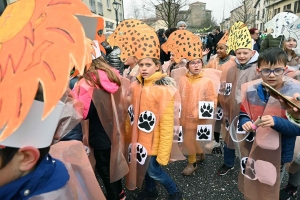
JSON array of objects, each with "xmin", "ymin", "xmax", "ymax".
[{"xmin": 145, "ymin": 0, "xmax": 188, "ymax": 28}]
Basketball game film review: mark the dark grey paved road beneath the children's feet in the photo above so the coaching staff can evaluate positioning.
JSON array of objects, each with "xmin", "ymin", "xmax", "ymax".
[{"xmin": 98, "ymin": 149, "xmax": 300, "ymax": 200}]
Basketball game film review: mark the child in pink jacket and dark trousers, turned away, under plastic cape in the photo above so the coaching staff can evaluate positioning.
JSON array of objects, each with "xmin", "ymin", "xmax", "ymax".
[{"xmin": 75, "ymin": 57, "xmax": 128, "ymax": 200}]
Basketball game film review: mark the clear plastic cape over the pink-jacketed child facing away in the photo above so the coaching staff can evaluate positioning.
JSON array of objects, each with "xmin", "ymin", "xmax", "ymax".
[{"xmin": 74, "ymin": 76, "xmax": 129, "ymax": 182}]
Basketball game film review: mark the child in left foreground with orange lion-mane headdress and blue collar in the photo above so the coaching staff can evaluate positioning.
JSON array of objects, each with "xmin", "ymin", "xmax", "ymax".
[{"xmin": 0, "ymin": 0, "xmax": 104, "ymax": 200}]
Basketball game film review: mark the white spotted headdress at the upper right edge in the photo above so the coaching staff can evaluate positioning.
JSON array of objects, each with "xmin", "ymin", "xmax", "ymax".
[{"xmin": 265, "ymin": 12, "xmax": 299, "ymax": 38}]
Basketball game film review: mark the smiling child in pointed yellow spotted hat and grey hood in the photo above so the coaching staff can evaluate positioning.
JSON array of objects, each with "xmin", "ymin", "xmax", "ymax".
[{"xmin": 217, "ymin": 22, "xmax": 259, "ymax": 175}]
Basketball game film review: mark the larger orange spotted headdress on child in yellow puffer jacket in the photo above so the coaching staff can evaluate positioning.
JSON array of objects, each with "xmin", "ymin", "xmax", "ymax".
[{"xmin": 107, "ymin": 19, "xmax": 160, "ymax": 62}]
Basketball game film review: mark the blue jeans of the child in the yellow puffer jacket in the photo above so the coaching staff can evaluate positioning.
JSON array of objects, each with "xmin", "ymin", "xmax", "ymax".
[{"xmin": 145, "ymin": 156, "xmax": 177, "ymax": 195}]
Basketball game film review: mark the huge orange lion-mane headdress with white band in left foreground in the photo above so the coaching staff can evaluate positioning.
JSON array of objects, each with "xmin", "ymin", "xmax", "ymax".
[{"xmin": 0, "ymin": 0, "xmax": 93, "ymax": 148}]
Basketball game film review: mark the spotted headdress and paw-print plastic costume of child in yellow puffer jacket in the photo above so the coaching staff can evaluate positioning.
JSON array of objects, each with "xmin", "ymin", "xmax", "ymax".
[{"xmin": 116, "ymin": 24, "xmax": 185, "ymax": 190}]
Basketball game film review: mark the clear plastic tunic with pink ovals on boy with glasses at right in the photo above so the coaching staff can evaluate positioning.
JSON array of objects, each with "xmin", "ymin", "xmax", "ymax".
[{"xmin": 239, "ymin": 77, "xmax": 300, "ymax": 199}]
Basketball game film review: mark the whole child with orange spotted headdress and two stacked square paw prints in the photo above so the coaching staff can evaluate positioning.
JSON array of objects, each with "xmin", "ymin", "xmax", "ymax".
[{"xmin": 162, "ymin": 30, "xmax": 217, "ymax": 176}]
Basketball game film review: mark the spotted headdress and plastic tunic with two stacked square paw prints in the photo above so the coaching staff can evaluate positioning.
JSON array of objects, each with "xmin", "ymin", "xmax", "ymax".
[{"xmin": 162, "ymin": 30, "xmax": 221, "ymax": 158}]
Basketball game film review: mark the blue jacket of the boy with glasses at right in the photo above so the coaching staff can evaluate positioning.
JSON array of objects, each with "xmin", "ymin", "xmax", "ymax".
[{"xmin": 239, "ymin": 85, "xmax": 300, "ymax": 163}]
